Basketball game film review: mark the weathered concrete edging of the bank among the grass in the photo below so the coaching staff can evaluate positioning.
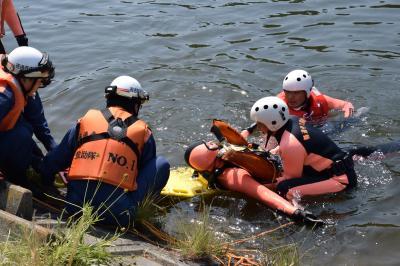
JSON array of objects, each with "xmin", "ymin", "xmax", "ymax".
[{"xmin": 0, "ymin": 183, "xmax": 198, "ymax": 266}]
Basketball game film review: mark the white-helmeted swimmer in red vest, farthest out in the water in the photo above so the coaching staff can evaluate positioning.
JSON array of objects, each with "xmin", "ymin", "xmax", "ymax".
[{"xmin": 242, "ymin": 69, "xmax": 354, "ymax": 138}]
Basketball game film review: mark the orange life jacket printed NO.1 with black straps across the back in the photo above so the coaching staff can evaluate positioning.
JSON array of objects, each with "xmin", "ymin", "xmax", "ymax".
[{"xmin": 68, "ymin": 109, "xmax": 147, "ymax": 191}]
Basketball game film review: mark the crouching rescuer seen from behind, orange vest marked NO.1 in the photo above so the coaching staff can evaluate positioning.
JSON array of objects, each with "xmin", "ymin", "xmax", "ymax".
[{"xmin": 41, "ymin": 76, "xmax": 170, "ymax": 227}]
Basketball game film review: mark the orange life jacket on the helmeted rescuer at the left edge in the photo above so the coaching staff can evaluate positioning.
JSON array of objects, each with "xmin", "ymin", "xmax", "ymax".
[{"xmin": 0, "ymin": 67, "xmax": 26, "ymax": 131}]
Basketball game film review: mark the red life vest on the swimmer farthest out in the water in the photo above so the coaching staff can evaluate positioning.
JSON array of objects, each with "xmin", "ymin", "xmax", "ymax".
[{"xmin": 277, "ymin": 90, "xmax": 329, "ymax": 121}]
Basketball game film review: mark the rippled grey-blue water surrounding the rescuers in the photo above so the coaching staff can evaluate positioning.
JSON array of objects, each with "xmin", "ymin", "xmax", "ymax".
[{"xmin": 5, "ymin": 0, "xmax": 400, "ymax": 265}]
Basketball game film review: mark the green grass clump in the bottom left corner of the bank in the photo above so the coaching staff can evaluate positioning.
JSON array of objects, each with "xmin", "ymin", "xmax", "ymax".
[{"xmin": 0, "ymin": 205, "xmax": 119, "ymax": 266}]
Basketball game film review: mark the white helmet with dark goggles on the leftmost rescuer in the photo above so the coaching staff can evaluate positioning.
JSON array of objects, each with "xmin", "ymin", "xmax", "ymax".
[{"xmin": 1, "ymin": 46, "xmax": 54, "ymax": 86}]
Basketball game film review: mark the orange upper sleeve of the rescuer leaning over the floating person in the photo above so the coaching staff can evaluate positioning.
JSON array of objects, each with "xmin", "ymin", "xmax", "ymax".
[{"xmin": 279, "ymin": 131, "xmax": 307, "ymax": 179}]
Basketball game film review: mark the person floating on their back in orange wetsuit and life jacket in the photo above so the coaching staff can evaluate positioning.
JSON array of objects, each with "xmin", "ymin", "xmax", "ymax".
[{"xmin": 185, "ymin": 120, "xmax": 323, "ymax": 224}]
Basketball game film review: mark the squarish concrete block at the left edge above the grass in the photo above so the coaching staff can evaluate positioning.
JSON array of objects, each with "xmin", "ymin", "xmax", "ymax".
[{"xmin": 0, "ymin": 182, "xmax": 33, "ymax": 220}]
